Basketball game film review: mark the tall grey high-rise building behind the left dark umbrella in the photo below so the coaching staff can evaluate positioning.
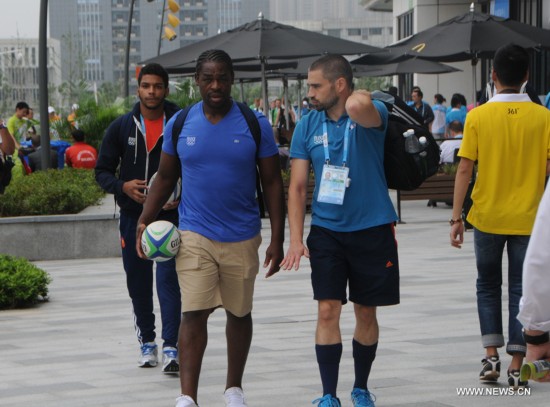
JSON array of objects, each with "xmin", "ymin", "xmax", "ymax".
[{"xmin": 49, "ymin": 0, "xmax": 269, "ymax": 94}]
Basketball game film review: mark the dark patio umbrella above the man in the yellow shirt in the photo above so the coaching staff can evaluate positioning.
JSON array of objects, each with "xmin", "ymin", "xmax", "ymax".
[{"xmin": 378, "ymin": 3, "xmax": 550, "ymax": 103}]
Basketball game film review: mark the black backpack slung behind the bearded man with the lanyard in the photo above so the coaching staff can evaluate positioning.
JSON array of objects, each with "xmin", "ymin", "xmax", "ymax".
[{"xmin": 371, "ymin": 91, "xmax": 440, "ymax": 191}]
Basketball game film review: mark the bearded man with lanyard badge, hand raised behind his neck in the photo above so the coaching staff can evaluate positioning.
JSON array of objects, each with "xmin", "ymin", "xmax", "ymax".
[{"xmin": 281, "ymin": 55, "xmax": 399, "ymax": 407}]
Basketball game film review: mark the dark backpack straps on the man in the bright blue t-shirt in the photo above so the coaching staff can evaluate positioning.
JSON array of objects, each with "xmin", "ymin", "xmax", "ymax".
[{"xmin": 171, "ymin": 102, "xmax": 265, "ymax": 218}]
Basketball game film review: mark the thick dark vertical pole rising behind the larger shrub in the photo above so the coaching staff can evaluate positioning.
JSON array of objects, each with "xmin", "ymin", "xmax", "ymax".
[{"xmin": 38, "ymin": 0, "xmax": 51, "ymax": 169}]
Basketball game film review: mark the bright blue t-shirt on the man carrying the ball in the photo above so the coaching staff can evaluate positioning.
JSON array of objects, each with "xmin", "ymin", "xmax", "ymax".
[{"xmin": 162, "ymin": 102, "xmax": 278, "ymax": 242}]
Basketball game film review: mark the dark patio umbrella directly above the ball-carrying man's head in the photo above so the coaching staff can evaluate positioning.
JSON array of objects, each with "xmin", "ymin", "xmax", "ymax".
[{"xmin": 141, "ymin": 13, "xmax": 381, "ymax": 112}]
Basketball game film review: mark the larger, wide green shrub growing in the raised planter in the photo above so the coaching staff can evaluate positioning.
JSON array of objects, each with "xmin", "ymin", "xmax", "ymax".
[{"xmin": 0, "ymin": 168, "xmax": 105, "ymax": 216}]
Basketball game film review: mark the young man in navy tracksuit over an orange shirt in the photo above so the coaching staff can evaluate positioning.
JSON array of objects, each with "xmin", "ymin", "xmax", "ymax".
[{"xmin": 95, "ymin": 64, "xmax": 181, "ymax": 373}]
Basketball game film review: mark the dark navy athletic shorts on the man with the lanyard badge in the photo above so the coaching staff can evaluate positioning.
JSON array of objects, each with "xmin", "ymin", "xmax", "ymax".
[{"xmin": 307, "ymin": 224, "xmax": 399, "ymax": 306}]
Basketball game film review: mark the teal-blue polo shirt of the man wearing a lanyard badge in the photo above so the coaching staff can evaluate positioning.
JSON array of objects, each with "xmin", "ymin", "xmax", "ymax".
[{"xmin": 290, "ymin": 100, "xmax": 397, "ymax": 232}]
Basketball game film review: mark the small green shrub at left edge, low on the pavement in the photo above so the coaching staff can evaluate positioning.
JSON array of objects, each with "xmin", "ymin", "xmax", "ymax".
[{"xmin": 0, "ymin": 254, "xmax": 51, "ymax": 309}]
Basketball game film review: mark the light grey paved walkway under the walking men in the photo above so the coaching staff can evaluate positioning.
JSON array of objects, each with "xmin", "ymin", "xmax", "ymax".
[{"xmin": 0, "ymin": 197, "xmax": 550, "ymax": 407}]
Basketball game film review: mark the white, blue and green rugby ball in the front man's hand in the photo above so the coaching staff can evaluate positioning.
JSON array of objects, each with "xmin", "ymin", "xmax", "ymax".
[{"xmin": 141, "ymin": 220, "xmax": 181, "ymax": 262}]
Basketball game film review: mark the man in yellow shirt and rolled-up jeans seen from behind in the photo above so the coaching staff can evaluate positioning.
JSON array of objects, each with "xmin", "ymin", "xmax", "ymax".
[{"xmin": 450, "ymin": 45, "xmax": 550, "ymax": 389}]
